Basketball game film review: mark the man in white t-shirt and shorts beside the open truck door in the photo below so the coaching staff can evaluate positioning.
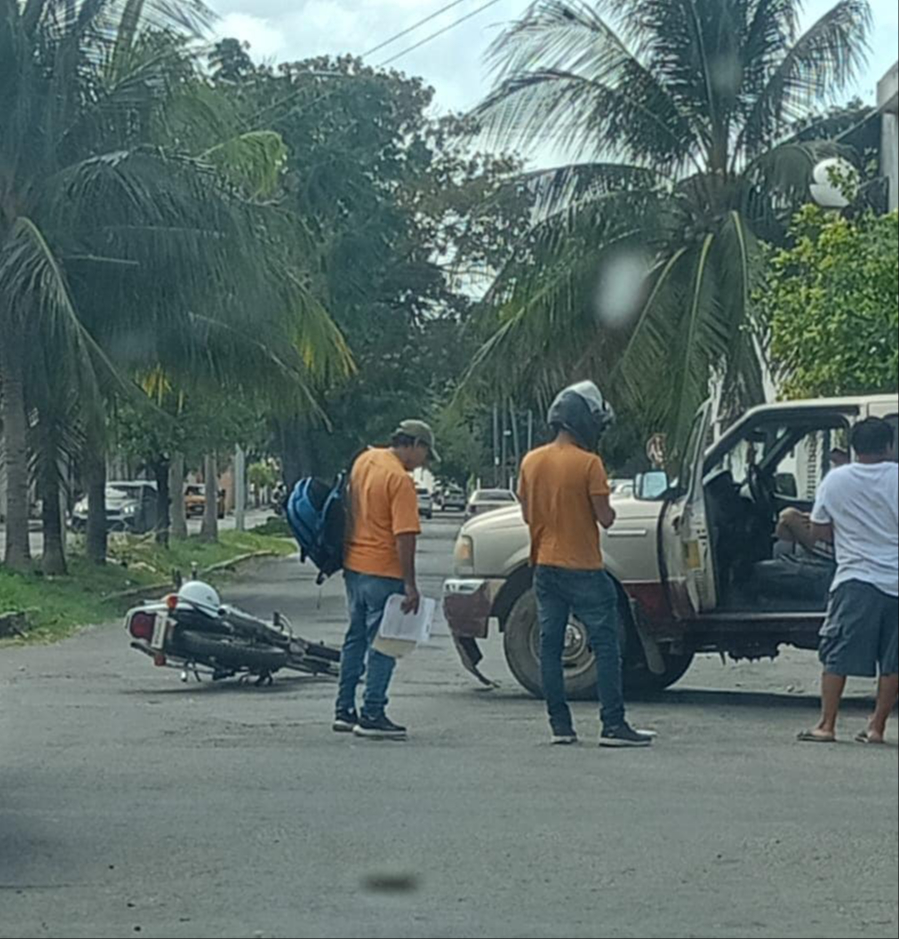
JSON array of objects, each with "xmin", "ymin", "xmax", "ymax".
[{"xmin": 799, "ymin": 418, "xmax": 899, "ymax": 744}]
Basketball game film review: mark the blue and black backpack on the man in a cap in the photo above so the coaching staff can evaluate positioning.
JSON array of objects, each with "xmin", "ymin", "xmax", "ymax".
[{"xmin": 284, "ymin": 473, "xmax": 349, "ymax": 586}]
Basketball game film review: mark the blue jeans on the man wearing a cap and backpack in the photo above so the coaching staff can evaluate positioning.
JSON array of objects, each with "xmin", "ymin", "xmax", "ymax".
[{"xmin": 337, "ymin": 571, "xmax": 405, "ymax": 720}]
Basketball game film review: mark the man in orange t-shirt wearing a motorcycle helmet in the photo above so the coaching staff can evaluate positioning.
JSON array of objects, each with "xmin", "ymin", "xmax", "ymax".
[{"xmin": 519, "ymin": 382, "xmax": 652, "ymax": 747}]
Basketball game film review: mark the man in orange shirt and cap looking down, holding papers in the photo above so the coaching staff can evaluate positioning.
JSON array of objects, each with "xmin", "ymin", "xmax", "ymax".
[{"xmin": 334, "ymin": 421, "xmax": 438, "ymax": 740}]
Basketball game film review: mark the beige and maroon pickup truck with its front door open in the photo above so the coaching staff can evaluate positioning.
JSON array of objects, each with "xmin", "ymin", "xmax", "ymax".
[{"xmin": 445, "ymin": 395, "xmax": 899, "ymax": 698}]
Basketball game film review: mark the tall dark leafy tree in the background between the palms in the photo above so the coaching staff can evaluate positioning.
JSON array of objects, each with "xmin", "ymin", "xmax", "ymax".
[{"xmin": 211, "ymin": 57, "xmax": 530, "ymax": 482}]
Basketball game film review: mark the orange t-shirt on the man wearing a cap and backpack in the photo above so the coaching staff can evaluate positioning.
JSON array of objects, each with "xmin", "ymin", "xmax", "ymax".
[{"xmin": 344, "ymin": 450, "xmax": 421, "ymax": 580}]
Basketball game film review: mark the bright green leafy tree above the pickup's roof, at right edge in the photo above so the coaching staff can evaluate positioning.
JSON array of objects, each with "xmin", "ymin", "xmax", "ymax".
[{"xmin": 756, "ymin": 206, "xmax": 899, "ymax": 398}]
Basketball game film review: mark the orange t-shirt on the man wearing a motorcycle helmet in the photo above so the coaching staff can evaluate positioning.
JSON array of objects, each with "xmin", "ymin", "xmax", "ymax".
[{"xmin": 519, "ymin": 443, "xmax": 612, "ymax": 571}]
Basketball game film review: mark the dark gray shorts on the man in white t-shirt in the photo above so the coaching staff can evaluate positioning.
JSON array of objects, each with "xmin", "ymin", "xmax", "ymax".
[{"xmin": 820, "ymin": 580, "xmax": 899, "ymax": 678}]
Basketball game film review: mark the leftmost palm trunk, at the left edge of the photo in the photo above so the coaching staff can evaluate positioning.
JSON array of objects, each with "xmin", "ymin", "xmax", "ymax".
[{"xmin": 0, "ymin": 326, "xmax": 31, "ymax": 571}]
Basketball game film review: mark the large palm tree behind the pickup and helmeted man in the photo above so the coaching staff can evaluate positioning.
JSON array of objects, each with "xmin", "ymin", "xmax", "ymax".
[{"xmin": 472, "ymin": 0, "xmax": 870, "ymax": 448}]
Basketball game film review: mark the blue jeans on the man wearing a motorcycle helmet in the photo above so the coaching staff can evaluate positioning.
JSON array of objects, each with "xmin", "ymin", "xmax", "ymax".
[{"xmin": 534, "ymin": 567, "xmax": 624, "ymax": 733}]
